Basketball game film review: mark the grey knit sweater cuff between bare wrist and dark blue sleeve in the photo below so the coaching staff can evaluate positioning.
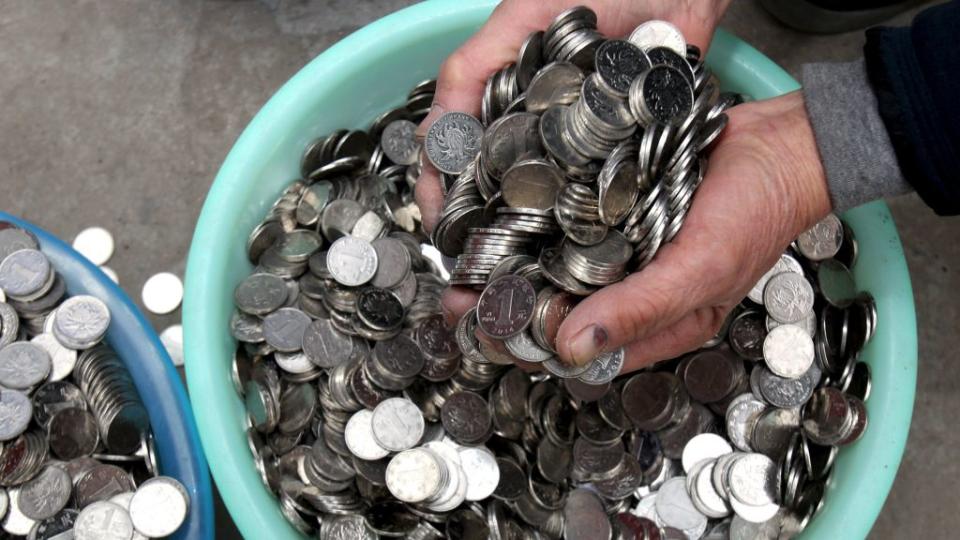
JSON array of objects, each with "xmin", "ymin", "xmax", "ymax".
[{"xmin": 803, "ymin": 59, "xmax": 913, "ymax": 212}]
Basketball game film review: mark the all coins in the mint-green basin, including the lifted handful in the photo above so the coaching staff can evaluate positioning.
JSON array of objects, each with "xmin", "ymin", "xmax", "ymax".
[{"xmin": 230, "ymin": 8, "xmax": 876, "ymax": 540}]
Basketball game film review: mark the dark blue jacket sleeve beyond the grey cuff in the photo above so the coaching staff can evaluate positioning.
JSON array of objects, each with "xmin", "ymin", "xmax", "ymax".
[{"xmin": 864, "ymin": 0, "xmax": 960, "ymax": 215}]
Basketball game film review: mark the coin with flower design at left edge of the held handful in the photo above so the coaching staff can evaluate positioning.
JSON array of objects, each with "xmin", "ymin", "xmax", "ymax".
[{"xmin": 424, "ymin": 112, "xmax": 483, "ymax": 174}]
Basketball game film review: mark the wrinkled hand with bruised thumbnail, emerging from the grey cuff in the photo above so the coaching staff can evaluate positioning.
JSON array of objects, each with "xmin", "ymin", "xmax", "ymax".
[{"xmin": 556, "ymin": 92, "xmax": 830, "ymax": 372}]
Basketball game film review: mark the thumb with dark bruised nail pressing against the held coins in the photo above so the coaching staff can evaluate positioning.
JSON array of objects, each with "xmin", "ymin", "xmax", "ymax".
[{"xmin": 557, "ymin": 231, "xmax": 725, "ymax": 364}]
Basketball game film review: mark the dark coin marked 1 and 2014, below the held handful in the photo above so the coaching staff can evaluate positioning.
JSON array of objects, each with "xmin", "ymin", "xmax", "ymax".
[{"xmin": 477, "ymin": 275, "xmax": 537, "ymax": 339}]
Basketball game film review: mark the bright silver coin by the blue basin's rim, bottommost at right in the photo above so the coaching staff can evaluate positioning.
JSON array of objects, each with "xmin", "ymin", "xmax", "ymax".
[{"xmin": 128, "ymin": 476, "xmax": 190, "ymax": 538}]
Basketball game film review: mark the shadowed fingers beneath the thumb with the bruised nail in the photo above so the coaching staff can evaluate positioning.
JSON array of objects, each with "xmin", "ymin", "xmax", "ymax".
[{"xmin": 621, "ymin": 308, "xmax": 727, "ymax": 373}]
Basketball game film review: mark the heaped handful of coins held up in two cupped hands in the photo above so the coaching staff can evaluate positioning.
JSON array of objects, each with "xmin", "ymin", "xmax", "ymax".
[{"xmin": 424, "ymin": 7, "xmax": 741, "ymax": 376}]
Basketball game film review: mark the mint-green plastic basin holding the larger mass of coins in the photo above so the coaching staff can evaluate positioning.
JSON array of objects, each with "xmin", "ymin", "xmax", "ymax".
[{"xmin": 183, "ymin": 0, "xmax": 917, "ymax": 539}]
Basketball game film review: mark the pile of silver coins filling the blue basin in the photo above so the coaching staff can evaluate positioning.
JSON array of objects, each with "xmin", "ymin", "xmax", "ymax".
[{"xmin": 0, "ymin": 223, "xmax": 190, "ymax": 540}]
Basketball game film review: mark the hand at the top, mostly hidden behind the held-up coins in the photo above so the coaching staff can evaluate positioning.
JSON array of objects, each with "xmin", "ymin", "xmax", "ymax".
[{"xmin": 416, "ymin": 0, "xmax": 731, "ymax": 230}]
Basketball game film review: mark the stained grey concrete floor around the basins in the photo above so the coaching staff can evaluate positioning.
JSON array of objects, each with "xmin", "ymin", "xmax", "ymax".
[{"xmin": 0, "ymin": 0, "xmax": 960, "ymax": 539}]
